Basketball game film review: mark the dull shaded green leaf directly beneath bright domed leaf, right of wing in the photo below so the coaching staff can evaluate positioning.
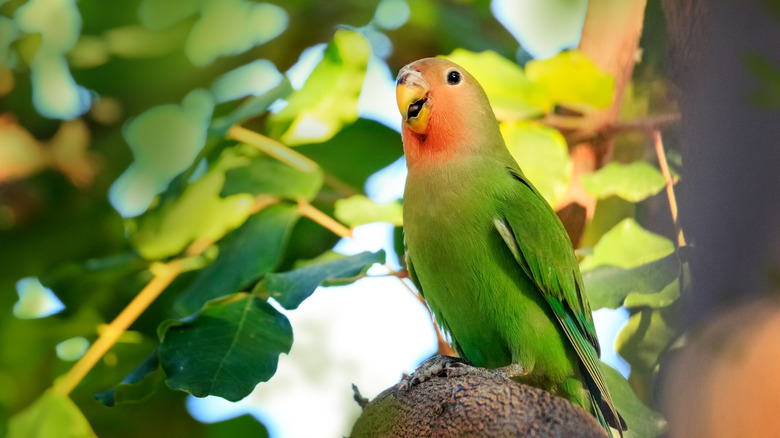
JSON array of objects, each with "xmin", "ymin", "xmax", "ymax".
[{"xmin": 582, "ymin": 248, "xmax": 681, "ymax": 310}]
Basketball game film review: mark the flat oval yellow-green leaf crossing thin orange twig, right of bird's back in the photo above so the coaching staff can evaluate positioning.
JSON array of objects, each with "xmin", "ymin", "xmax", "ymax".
[{"xmin": 582, "ymin": 161, "xmax": 666, "ymax": 202}]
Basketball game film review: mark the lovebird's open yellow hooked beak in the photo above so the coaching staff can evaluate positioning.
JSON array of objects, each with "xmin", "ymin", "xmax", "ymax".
[{"xmin": 395, "ymin": 69, "xmax": 431, "ymax": 134}]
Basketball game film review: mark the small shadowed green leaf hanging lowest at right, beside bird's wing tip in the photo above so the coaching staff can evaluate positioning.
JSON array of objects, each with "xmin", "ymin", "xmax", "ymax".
[{"xmin": 615, "ymin": 309, "xmax": 675, "ymax": 374}]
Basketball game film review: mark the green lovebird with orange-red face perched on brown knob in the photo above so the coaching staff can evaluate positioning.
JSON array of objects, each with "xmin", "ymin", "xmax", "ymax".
[{"xmin": 396, "ymin": 58, "xmax": 626, "ymax": 436}]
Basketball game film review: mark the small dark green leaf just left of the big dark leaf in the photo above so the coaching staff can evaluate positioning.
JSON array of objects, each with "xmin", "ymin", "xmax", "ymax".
[{"xmin": 94, "ymin": 348, "xmax": 164, "ymax": 407}]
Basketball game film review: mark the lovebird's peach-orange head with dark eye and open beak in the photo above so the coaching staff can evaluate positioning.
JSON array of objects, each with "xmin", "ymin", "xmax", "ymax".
[{"xmin": 396, "ymin": 58, "xmax": 500, "ymax": 164}]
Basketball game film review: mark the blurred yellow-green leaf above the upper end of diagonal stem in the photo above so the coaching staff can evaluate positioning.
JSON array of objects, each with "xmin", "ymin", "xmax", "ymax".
[{"xmin": 127, "ymin": 151, "xmax": 254, "ymax": 260}]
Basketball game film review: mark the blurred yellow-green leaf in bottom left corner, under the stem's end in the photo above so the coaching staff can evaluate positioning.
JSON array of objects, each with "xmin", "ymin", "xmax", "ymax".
[{"xmin": 7, "ymin": 391, "xmax": 97, "ymax": 438}]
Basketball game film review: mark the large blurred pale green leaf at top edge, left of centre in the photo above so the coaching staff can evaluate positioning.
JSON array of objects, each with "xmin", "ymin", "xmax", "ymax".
[{"xmin": 184, "ymin": 0, "xmax": 289, "ymax": 67}]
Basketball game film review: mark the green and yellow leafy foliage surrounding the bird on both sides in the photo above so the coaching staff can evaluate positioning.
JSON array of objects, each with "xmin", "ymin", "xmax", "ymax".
[{"xmin": 0, "ymin": 0, "xmax": 686, "ymax": 438}]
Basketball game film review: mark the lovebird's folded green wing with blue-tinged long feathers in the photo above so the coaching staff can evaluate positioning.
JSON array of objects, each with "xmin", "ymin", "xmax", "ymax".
[{"xmin": 495, "ymin": 168, "xmax": 625, "ymax": 429}]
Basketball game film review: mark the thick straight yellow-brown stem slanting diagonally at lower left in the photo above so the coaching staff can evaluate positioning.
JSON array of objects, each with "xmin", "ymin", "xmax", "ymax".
[{"xmin": 52, "ymin": 260, "xmax": 181, "ymax": 396}]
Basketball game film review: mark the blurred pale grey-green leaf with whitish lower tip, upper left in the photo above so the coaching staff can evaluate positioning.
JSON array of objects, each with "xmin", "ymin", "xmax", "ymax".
[{"xmin": 109, "ymin": 89, "xmax": 214, "ymax": 217}]
